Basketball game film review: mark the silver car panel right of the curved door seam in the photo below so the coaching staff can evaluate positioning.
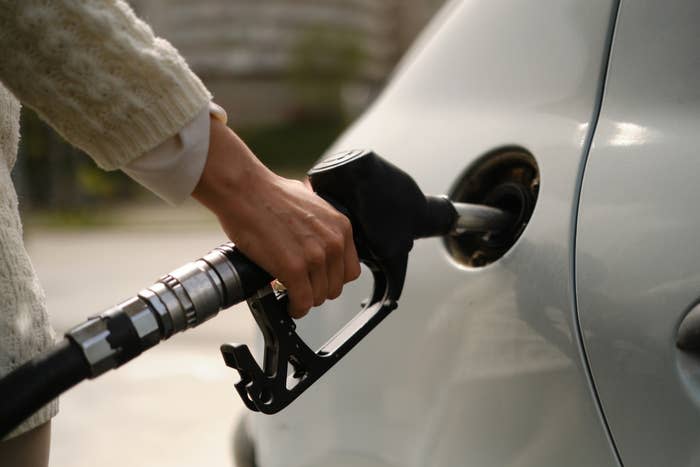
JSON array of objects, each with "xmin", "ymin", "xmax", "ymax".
[{"xmin": 576, "ymin": 0, "xmax": 700, "ymax": 466}]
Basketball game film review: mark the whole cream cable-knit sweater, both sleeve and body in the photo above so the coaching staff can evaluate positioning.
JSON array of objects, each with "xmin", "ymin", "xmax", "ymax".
[{"xmin": 0, "ymin": 0, "xmax": 211, "ymax": 435}]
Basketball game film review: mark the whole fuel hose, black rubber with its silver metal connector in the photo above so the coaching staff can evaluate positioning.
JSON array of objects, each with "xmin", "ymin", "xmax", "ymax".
[{"xmin": 0, "ymin": 247, "xmax": 271, "ymax": 439}]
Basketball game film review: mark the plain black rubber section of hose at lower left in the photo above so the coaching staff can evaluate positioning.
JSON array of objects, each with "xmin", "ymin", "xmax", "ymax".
[{"xmin": 0, "ymin": 339, "xmax": 90, "ymax": 439}]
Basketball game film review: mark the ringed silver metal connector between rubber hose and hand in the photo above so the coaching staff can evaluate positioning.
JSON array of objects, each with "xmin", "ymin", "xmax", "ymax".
[{"xmin": 66, "ymin": 243, "xmax": 269, "ymax": 378}]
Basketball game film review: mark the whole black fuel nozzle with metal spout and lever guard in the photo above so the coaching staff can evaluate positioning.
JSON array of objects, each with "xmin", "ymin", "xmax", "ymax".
[{"xmin": 221, "ymin": 150, "xmax": 507, "ymax": 414}]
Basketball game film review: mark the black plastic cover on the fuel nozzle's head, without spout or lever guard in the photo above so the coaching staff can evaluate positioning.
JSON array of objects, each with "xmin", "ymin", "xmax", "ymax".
[{"xmin": 309, "ymin": 150, "xmax": 457, "ymax": 300}]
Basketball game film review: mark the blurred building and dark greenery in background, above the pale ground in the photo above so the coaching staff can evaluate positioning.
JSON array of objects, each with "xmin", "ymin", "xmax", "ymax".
[{"xmin": 14, "ymin": 0, "xmax": 444, "ymax": 216}]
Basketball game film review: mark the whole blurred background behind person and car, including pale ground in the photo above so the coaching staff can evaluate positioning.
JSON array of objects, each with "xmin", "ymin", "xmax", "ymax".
[{"xmin": 13, "ymin": 0, "xmax": 444, "ymax": 467}]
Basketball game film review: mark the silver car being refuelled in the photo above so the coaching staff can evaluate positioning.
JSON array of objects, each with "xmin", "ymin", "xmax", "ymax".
[{"xmin": 237, "ymin": 0, "xmax": 700, "ymax": 467}]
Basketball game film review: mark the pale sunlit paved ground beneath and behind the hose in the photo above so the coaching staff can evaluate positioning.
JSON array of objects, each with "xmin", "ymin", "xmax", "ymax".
[{"xmin": 27, "ymin": 207, "xmax": 255, "ymax": 467}]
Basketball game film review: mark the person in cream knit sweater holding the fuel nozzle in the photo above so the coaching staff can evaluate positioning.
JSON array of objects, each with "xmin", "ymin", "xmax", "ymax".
[{"xmin": 0, "ymin": 0, "xmax": 360, "ymax": 466}]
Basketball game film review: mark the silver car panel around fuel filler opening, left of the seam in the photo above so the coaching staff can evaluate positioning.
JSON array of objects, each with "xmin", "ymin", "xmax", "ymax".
[{"xmin": 251, "ymin": 0, "xmax": 617, "ymax": 467}]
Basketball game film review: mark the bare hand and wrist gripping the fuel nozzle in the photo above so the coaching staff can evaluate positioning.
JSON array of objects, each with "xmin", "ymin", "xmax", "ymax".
[{"xmin": 192, "ymin": 119, "xmax": 360, "ymax": 318}]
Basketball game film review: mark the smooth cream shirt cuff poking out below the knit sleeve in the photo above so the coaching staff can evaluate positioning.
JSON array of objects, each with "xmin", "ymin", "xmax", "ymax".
[{"xmin": 122, "ymin": 102, "xmax": 227, "ymax": 205}]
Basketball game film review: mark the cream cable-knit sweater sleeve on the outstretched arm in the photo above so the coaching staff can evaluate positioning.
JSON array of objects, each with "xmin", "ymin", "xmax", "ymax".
[{"xmin": 0, "ymin": 0, "xmax": 211, "ymax": 170}]
